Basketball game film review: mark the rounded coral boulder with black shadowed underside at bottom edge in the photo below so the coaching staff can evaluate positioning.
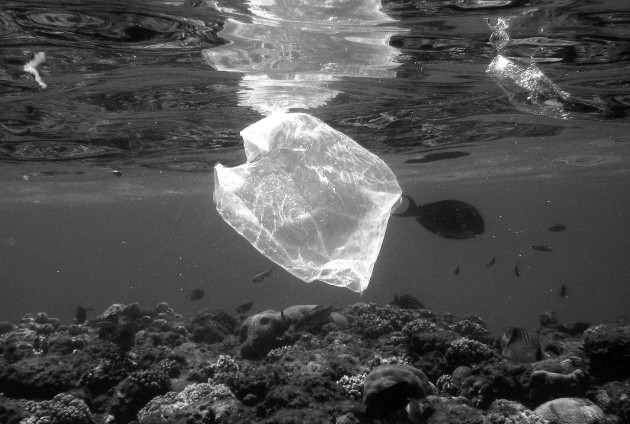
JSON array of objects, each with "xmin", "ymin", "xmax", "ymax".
[{"xmin": 363, "ymin": 364, "xmax": 435, "ymax": 418}]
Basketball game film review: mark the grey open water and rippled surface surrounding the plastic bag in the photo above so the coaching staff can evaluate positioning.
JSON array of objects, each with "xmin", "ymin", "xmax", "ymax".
[{"xmin": 0, "ymin": 0, "xmax": 630, "ymax": 329}]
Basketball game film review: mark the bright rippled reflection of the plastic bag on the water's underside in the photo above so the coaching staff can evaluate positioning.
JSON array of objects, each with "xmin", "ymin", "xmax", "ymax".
[{"xmin": 203, "ymin": 0, "xmax": 402, "ymax": 115}]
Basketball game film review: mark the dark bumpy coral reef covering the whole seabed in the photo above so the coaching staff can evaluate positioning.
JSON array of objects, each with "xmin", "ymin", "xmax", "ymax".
[{"xmin": 0, "ymin": 303, "xmax": 630, "ymax": 424}]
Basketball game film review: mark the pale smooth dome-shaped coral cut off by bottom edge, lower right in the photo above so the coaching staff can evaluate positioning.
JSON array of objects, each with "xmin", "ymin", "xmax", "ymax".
[{"xmin": 534, "ymin": 398, "xmax": 604, "ymax": 424}]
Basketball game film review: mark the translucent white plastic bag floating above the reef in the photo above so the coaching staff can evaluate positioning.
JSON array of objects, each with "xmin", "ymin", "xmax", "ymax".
[{"xmin": 214, "ymin": 113, "xmax": 401, "ymax": 292}]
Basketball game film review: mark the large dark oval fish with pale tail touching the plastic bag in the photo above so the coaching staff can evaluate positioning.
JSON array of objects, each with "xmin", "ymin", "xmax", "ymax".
[{"xmin": 394, "ymin": 194, "xmax": 485, "ymax": 240}]
